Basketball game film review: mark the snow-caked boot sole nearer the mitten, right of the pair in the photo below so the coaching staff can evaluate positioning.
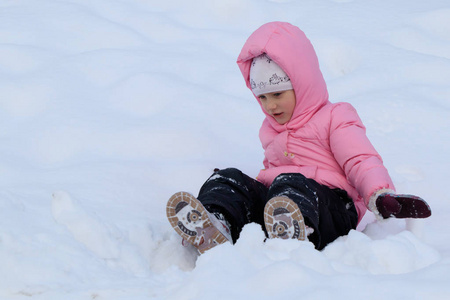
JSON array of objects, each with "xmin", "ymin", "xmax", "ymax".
[{"xmin": 264, "ymin": 197, "xmax": 307, "ymax": 241}]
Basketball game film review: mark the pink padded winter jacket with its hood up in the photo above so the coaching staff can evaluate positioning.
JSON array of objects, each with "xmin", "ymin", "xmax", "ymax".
[{"xmin": 237, "ymin": 22, "xmax": 395, "ymax": 221}]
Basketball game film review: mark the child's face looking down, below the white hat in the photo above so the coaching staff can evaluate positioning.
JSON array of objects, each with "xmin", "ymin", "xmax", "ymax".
[{"xmin": 258, "ymin": 90, "xmax": 295, "ymax": 125}]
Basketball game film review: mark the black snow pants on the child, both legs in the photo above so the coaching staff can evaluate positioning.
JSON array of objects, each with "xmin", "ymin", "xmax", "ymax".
[{"xmin": 197, "ymin": 168, "xmax": 358, "ymax": 250}]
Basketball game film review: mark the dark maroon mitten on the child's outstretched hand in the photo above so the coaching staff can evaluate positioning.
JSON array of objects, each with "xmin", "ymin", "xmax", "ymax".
[{"xmin": 376, "ymin": 193, "xmax": 431, "ymax": 219}]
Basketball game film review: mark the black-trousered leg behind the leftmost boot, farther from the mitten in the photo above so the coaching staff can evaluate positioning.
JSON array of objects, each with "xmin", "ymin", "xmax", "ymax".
[{"xmin": 198, "ymin": 168, "xmax": 268, "ymax": 242}]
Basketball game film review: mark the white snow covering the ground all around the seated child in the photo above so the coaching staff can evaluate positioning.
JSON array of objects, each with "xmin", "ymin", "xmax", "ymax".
[{"xmin": 0, "ymin": 0, "xmax": 450, "ymax": 300}]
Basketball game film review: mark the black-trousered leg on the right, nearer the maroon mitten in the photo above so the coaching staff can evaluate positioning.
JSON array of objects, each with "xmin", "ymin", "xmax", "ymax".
[{"xmin": 268, "ymin": 173, "xmax": 358, "ymax": 249}]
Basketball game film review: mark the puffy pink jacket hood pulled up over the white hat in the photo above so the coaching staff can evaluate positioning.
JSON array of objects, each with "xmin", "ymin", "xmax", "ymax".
[{"xmin": 237, "ymin": 22, "xmax": 328, "ymax": 132}]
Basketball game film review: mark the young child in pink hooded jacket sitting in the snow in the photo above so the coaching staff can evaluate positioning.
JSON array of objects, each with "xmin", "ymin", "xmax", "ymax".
[{"xmin": 167, "ymin": 22, "xmax": 431, "ymax": 253}]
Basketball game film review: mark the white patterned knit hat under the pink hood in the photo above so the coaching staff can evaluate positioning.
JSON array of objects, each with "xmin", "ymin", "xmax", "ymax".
[{"xmin": 250, "ymin": 53, "xmax": 293, "ymax": 96}]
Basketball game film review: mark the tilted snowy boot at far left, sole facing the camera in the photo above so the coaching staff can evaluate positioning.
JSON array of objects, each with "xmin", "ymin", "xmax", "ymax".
[{"xmin": 166, "ymin": 192, "xmax": 232, "ymax": 254}]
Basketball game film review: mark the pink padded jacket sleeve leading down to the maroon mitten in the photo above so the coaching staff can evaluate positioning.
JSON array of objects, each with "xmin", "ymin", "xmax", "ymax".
[{"xmin": 330, "ymin": 103, "xmax": 395, "ymax": 208}]
